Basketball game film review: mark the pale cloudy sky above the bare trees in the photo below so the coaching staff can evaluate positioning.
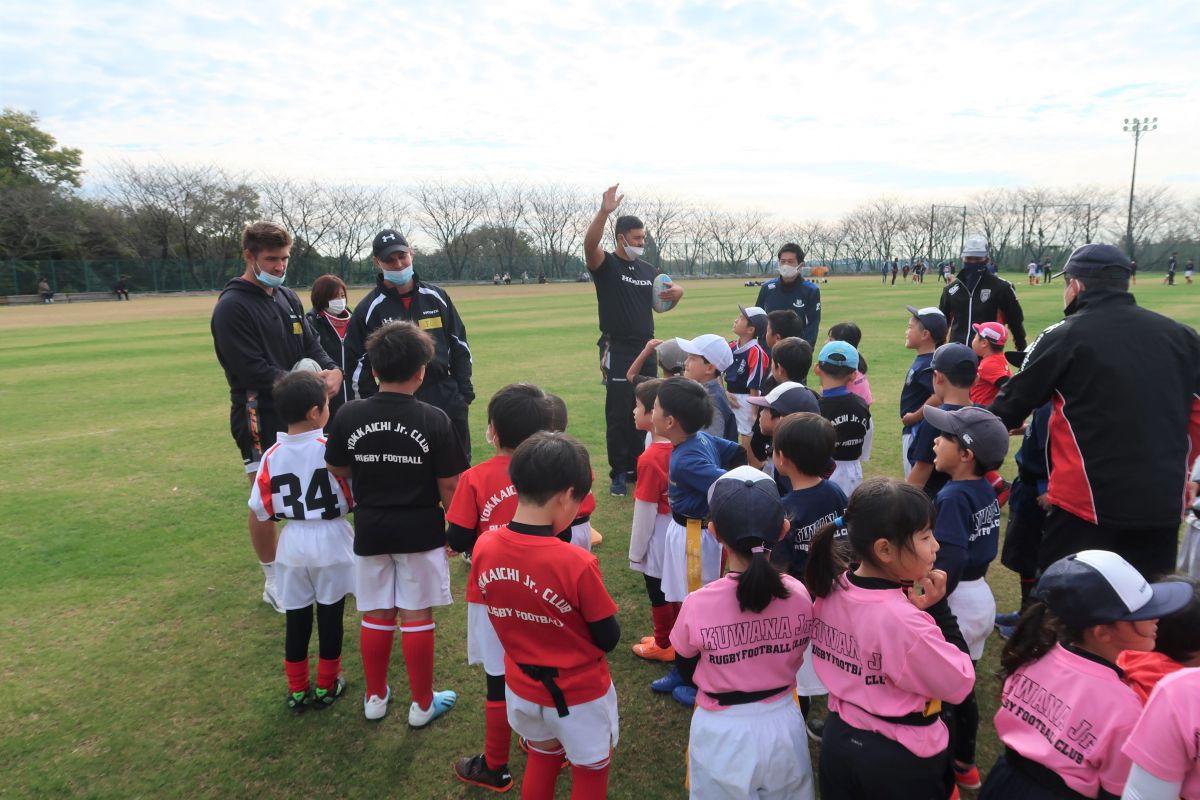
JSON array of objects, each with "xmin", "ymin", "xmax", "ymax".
[{"xmin": 0, "ymin": 0, "xmax": 1200, "ymax": 219}]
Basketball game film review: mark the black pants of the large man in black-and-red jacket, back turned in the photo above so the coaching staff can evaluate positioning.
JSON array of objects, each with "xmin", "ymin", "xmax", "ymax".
[{"xmin": 1038, "ymin": 509, "xmax": 1180, "ymax": 581}]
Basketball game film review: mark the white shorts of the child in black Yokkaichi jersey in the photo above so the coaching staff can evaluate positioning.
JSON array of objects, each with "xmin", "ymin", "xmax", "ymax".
[{"xmin": 354, "ymin": 547, "xmax": 451, "ymax": 610}]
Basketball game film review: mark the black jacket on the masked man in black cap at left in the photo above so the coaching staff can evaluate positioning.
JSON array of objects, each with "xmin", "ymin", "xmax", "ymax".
[{"xmin": 346, "ymin": 275, "xmax": 475, "ymax": 416}]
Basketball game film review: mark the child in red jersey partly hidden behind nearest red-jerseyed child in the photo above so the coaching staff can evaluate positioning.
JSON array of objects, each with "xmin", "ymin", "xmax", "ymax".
[{"xmin": 446, "ymin": 384, "xmax": 550, "ymax": 792}]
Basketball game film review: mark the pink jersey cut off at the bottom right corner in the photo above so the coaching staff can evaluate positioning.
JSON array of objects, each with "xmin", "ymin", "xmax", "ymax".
[{"xmin": 1122, "ymin": 669, "xmax": 1200, "ymax": 800}]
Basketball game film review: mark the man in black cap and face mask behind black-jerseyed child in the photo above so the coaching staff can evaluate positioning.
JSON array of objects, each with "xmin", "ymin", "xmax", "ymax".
[{"xmin": 346, "ymin": 229, "xmax": 475, "ymax": 457}]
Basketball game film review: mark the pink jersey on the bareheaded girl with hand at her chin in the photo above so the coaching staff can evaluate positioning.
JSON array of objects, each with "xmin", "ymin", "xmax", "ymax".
[{"xmin": 812, "ymin": 575, "xmax": 974, "ymax": 758}]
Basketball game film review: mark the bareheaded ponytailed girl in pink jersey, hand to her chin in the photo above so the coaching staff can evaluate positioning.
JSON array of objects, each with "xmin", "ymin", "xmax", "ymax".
[{"xmin": 804, "ymin": 479, "xmax": 974, "ymax": 800}]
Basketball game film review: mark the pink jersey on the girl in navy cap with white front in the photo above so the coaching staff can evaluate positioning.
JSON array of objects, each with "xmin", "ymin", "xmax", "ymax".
[{"xmin": 995, "ymin": 644, "xmax": 1141, "ymax": 798}]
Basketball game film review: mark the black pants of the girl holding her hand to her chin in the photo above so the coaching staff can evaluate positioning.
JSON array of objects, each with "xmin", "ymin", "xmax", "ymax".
[{"xmin": 821, "ymin": 712, "xmax": 954, "ymax": 800}]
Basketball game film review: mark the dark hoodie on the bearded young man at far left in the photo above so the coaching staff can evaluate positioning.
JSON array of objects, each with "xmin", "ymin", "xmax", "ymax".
[{"xmin": 210, "ymin": 277, "xmax": 337, "ymax": 408}]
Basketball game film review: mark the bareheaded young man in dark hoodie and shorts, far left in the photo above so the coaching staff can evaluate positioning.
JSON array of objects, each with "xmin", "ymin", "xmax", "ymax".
[{"xmin": 211, "ymin": 222, "xmax": 342, "ymax": 613}]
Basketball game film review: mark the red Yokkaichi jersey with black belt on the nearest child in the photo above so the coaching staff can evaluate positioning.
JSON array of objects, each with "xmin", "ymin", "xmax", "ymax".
[{"xmin": 468, "ymin": 528, "xmax": 617, "ymax": 708}]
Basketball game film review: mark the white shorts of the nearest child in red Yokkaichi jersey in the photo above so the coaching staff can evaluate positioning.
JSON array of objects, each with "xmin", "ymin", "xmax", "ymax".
[{"xmin": 504, "ymin": 684, "xmax": 620, "ymax": 766}]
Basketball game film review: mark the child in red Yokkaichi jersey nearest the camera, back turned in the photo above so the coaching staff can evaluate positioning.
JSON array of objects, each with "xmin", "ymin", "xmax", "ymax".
[{"xmin": 468, "ymin": 432, "xmax": 620, "ymax": 800}]
